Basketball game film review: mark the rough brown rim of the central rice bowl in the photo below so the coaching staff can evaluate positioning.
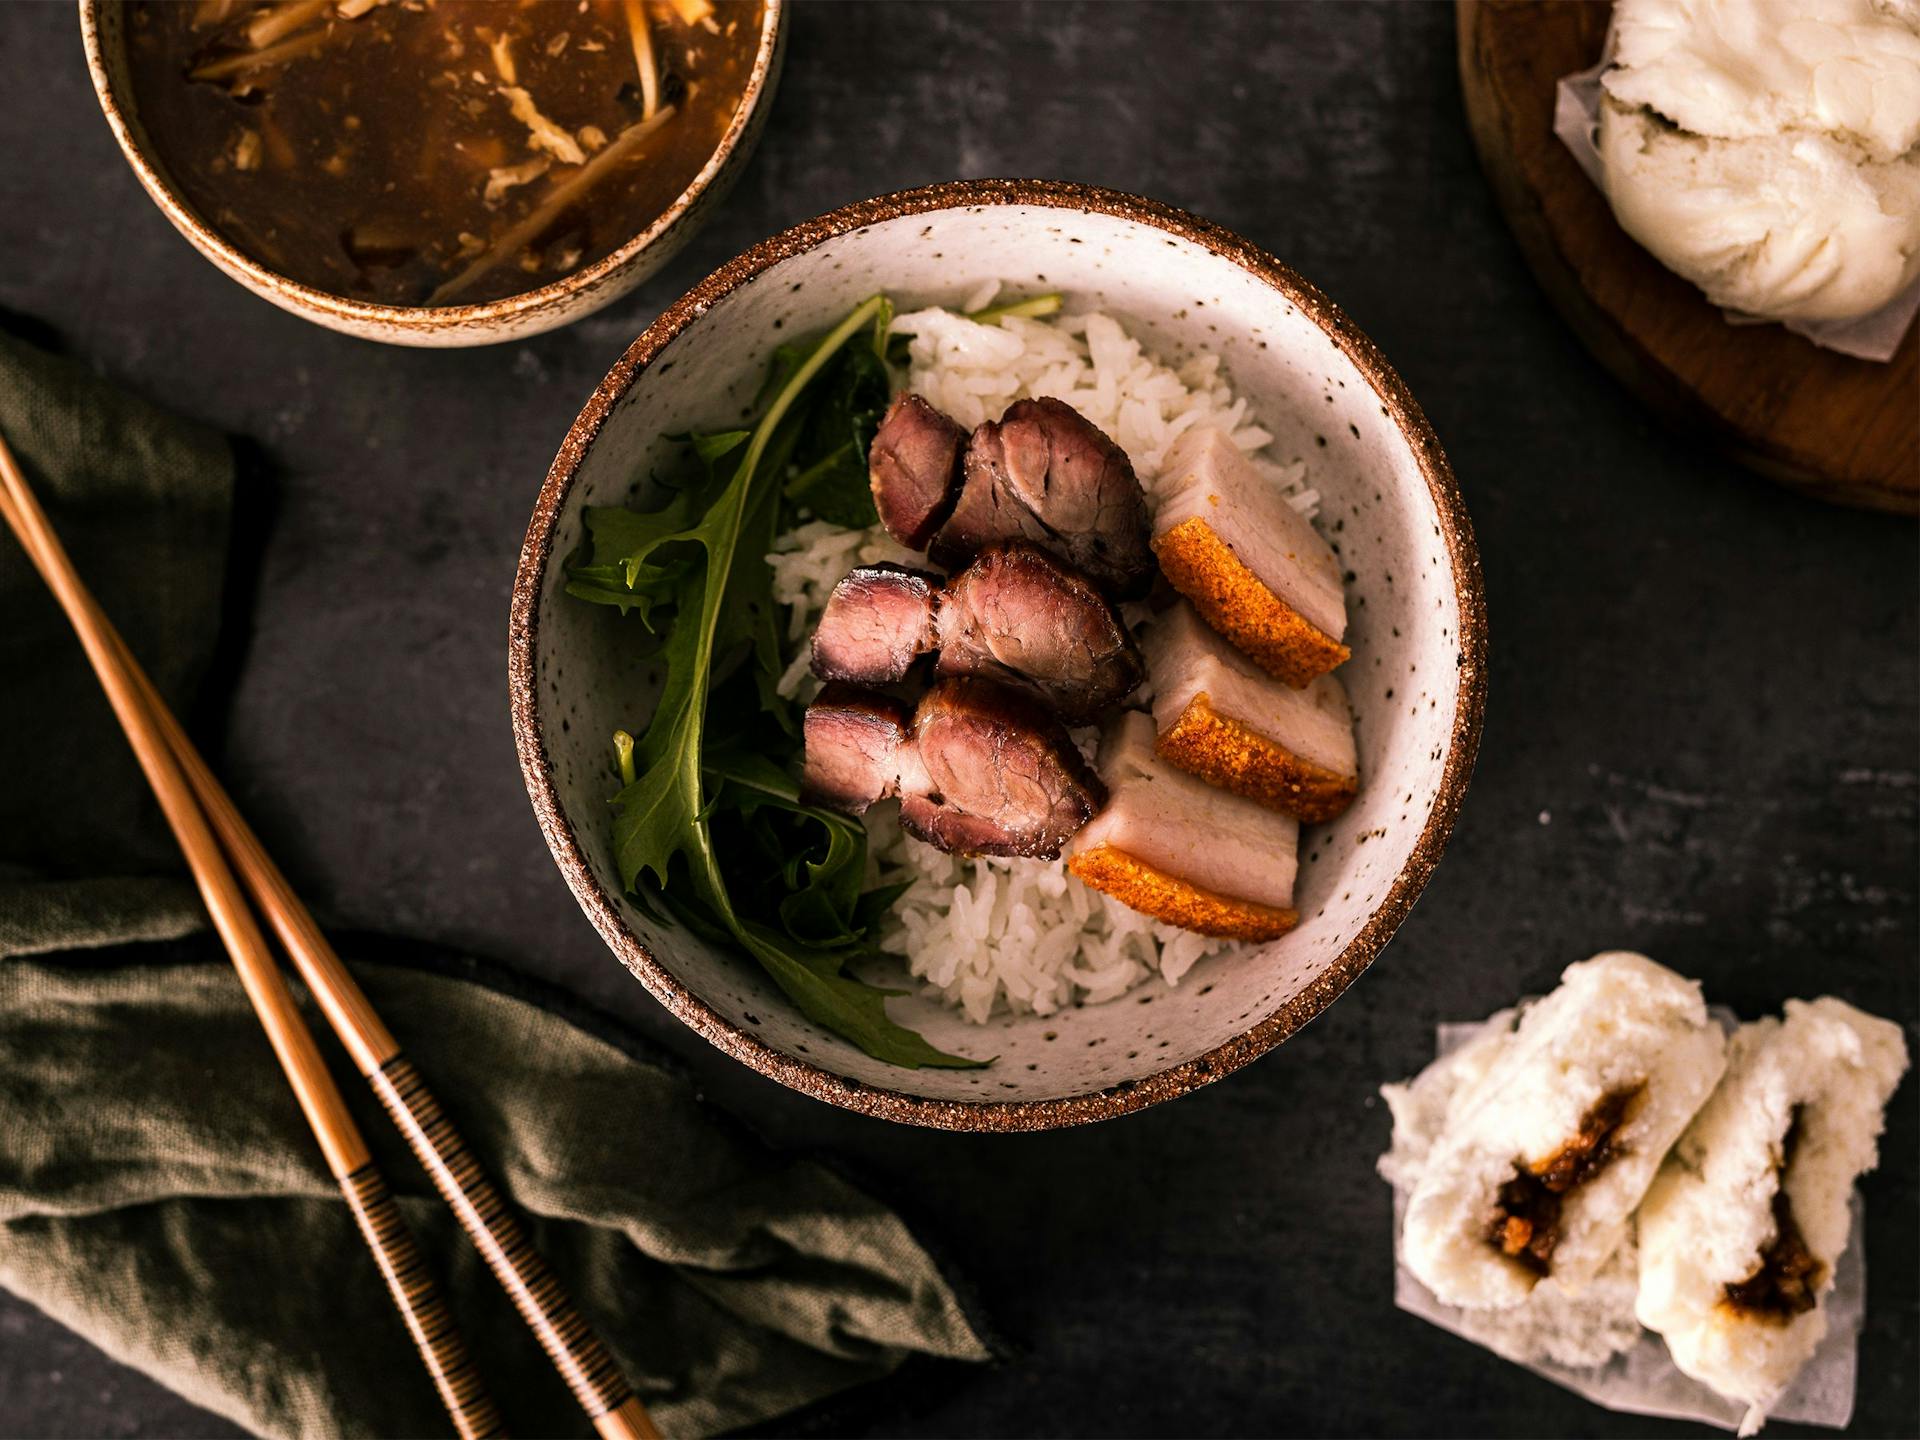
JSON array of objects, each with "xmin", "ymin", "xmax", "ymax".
[{"xmin": 507, "ymin": 180, "xmax": 1486, "ymax": 1133}]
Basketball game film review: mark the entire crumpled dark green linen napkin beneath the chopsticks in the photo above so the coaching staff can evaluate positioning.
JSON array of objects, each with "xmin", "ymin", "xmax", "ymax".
[{"xmin": 0, "ymin": 336, "xmax": 989, "ymax": 1440}]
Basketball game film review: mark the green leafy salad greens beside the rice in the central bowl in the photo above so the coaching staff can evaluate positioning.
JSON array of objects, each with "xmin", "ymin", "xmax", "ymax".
[{"xmin": 587, "ymin": 296, "xmax": 985, "ymax": 1066}]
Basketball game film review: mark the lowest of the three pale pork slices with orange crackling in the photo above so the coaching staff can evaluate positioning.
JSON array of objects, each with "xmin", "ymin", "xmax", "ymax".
[{"xmin": 1068, "ymin": 710, "xmax": 1300, "ymax": 941}]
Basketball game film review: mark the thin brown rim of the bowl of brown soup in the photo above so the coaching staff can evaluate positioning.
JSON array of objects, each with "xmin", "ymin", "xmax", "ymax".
[{"xmin": 79, "ymin": 0, "xmax": 787, "ymax": 330}]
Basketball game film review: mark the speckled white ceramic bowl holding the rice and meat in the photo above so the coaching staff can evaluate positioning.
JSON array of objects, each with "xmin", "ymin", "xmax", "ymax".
[{"xmin": 509, "ymin": 180, "xmax": 1486, "ymax": 1131}]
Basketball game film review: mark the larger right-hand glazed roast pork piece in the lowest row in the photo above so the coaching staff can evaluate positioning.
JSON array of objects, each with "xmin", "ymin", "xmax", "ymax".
[{"xmin": 900, "ymin": 676, "xmax": 1106, "ymax": 860}]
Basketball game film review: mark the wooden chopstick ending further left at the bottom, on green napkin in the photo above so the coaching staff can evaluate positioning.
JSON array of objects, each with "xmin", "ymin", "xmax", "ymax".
[{"xmin": 0, "ymin": 449, "xmax": 505, "ymax": 1440}]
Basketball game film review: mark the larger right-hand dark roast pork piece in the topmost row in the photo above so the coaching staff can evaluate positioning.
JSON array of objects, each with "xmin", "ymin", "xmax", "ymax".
[{"xmin": 927, "ymin": 397, "xmax": 1154, "ymax": 597}]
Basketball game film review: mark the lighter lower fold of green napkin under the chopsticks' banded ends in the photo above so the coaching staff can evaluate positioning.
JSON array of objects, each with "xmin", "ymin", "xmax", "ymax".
[{"xmin": 0, "ymin": 960, "xmax": 989, "ymax": 1440}]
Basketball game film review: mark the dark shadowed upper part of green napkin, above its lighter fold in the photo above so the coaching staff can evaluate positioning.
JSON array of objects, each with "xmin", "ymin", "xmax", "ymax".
[{"xmin": 0, "ymin": 330, "xmax": 234, "ymax": 956}]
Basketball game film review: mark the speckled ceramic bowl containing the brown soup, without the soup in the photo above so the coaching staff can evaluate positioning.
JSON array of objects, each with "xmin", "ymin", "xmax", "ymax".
[{"xmin": 79, "ymin": 0, "xmax": 787, "ymax": 348}]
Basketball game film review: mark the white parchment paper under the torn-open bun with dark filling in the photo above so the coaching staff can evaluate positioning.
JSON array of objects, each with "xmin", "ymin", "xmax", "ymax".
[{"xmin": 1394, "ymin": 1006, "xmax": 1866, "ymax": 1430}]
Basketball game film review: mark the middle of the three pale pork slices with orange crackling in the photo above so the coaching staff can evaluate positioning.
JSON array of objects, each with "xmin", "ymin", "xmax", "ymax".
[{"xmin": 1140, "ymin": 601, "xmax": 1359, "ymax": 822}]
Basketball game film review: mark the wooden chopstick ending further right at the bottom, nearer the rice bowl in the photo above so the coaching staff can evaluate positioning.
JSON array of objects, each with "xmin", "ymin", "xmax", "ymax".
[{"xmin": 0, "ymin": 440, "xmax": 659, "ymax": 1440}]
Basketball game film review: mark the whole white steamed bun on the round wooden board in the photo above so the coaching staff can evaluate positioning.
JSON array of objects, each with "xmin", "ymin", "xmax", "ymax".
[{"xmin": 1599, "ymin": 0, "xmax": 1920, "ymax": 321}]
